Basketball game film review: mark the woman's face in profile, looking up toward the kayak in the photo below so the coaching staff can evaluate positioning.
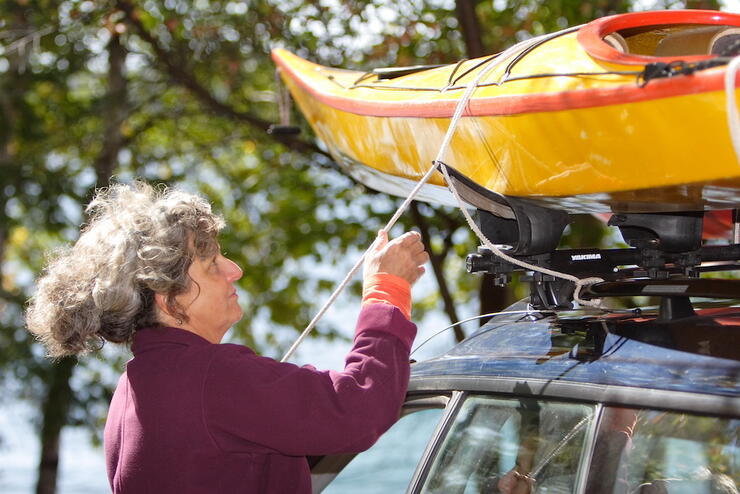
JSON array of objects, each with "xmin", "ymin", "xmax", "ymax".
[{"xmin": 175, "ymin": 249, "xmax": 242, "ymax": 343}]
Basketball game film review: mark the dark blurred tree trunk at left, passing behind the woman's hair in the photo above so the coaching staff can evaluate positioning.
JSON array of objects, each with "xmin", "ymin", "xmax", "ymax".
[{"xmin": 36, "ymin": 29, "xmax": 129, "ymax": 494}]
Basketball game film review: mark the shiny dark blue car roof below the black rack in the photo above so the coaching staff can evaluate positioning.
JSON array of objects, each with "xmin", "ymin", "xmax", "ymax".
[{"xmin": 410, "ymin": 305, "xmax": 740, "ymax": 415}]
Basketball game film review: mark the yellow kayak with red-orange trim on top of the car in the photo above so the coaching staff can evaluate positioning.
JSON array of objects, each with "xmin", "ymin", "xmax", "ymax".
[{"xmin": 273, "ymin": 10, "xmax": 740, "ymax": 212}]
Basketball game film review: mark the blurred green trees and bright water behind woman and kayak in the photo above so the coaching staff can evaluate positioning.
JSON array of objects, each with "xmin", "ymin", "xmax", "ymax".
[{"xmin": 0, "ymin": 0, "xmax": 740, "ymax": 494}]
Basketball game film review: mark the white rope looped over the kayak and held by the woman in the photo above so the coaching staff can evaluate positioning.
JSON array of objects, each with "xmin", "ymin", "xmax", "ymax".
[{"xmin": 280, "ymin": 35, "xmax": 603, "ymax": 362}]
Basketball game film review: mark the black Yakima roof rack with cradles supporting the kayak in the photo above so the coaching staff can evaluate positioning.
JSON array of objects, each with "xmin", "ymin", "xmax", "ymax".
[{"xmin": 448, "ymin": 168, "xmax": 740, "ymax": 312}]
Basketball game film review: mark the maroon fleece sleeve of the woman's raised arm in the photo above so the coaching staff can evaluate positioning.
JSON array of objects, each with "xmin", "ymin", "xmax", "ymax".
[{"xmin": 203, "ymin": 304, "xmax": 416, "ymax": 456}]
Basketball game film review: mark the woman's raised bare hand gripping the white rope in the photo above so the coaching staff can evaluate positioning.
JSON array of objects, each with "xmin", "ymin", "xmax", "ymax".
[{"xmin": 363, "ymin": 230, "xmax": 429, "ymax": 285}]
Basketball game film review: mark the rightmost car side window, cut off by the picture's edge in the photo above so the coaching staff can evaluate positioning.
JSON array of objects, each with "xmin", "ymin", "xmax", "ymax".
[{"xmin": 587, "ymin": 407, "xmax": 740, "ymax": 494}]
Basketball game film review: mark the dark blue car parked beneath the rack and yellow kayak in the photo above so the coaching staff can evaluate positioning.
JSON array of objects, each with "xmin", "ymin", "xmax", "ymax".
[{"xmin": 312, "ymin": 208, "xmax": 740, "ymax": 494}]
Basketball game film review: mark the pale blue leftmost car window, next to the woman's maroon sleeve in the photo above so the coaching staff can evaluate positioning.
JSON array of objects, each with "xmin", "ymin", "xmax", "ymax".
[{"xmin": 312, "ymin": 408, "xmax": 444, "ymax": 494}]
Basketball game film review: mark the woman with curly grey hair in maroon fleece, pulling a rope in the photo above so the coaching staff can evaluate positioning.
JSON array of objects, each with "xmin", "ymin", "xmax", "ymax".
[{"xmin": 27, "ymin": 183, "xmax": 428, "ymax": 494}]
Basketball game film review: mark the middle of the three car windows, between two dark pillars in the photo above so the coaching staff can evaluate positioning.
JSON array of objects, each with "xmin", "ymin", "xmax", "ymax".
[{"xmin": 422, "ymin": 396, "xmax": 595, "ymax": 494}]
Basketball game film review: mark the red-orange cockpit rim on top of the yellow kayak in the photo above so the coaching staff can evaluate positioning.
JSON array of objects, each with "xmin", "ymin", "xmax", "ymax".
[{"xmin": 577, "ymin": 10, "xmax": 740, "ymax": 65}]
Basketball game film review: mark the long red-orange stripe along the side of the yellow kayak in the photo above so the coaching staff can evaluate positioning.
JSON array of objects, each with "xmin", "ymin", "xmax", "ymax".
[{"xmin": 273, "ymin": 48, "xmax": 740, "ymax": 118}]
